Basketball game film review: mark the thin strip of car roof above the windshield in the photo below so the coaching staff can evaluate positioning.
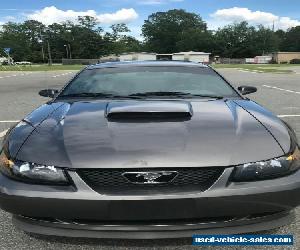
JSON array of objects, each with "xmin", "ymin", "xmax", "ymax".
[{"xmin": 86, "ymin": 61, "xmax": 208, "ymax": 69}]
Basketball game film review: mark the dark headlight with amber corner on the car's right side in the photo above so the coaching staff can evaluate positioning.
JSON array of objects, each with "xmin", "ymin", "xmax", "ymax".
[{"xmin": 231, "ymin": 146, "xmax": 300, "ymax": 181}]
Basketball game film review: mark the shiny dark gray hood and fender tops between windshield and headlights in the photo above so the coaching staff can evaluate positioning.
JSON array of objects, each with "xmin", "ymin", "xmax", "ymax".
[{"xmin": 9, "ymin": 100, "xmax": 290, "ymax": 168}]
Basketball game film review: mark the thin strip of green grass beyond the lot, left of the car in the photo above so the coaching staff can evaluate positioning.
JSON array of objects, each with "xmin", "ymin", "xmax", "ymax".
[{"xmin": 0, "ymin": 64, "xmax": 85, "ymax": 71}]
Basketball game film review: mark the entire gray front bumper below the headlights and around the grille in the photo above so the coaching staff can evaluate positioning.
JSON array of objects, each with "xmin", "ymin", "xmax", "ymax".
[{"xmin": 0, "ymin": 168, "xmax": 300, "ymax": 238}]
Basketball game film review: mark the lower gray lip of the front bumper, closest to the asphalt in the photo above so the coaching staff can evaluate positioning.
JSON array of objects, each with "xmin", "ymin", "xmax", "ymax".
[{"xmin": 13, "ymin": 212, "xmax": 295, "ymax": 239}]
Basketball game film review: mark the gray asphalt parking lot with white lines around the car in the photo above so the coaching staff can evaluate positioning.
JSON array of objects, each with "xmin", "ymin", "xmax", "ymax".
[{"xmin": 0, "ymin": 67, "xmax": 300, "ymax": 250}]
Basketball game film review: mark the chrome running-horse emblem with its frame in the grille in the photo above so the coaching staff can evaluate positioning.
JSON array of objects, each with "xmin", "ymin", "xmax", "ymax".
[{"xmin": 122, "ymin": 171, "xmax": 178, "ymax": 184}]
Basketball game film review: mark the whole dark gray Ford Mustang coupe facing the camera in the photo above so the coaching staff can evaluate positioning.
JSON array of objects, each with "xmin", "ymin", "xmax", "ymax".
[{"xmin": 0, "ymin": 61, "xmax": 300, "ymax": 238}]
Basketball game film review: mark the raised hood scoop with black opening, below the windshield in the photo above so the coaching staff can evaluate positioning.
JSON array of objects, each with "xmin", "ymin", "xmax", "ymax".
[{"xmin": 105, "ymin": 101, "xmax": 193, "ymax": 122}]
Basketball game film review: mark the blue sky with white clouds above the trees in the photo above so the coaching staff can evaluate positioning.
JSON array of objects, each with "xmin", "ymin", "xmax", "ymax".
[{"xmin": 0, "ymin": 0, "xmax": 300, "ymax": 40}]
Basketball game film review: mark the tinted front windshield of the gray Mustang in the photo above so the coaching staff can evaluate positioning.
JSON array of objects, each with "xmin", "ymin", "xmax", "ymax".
[{"xmin": 60, "ymin": 66, "xmax": 238, "ymax": 97}]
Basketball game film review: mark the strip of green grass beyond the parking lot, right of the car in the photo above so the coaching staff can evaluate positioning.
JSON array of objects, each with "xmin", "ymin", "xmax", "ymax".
[{"xmin": 213, "ymin": 64, "xmax": 300, "ymax": 74}]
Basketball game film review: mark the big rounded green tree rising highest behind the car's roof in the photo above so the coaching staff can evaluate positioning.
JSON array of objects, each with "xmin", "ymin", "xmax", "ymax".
[{"xmin": 142, "ymin": 9, "xmax": 207, "ymax": 53}]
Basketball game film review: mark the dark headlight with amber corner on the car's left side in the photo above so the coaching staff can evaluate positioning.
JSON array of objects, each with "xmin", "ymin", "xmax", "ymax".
[{"xmin": 0, "ymin": 151, "xmax": 69, "ymax": 185}]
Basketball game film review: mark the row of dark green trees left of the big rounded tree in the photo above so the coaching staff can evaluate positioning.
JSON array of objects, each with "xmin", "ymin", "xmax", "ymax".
[{"xmin": 0, "ymin": 16, "xmax": 140, "ymax": 62}]
